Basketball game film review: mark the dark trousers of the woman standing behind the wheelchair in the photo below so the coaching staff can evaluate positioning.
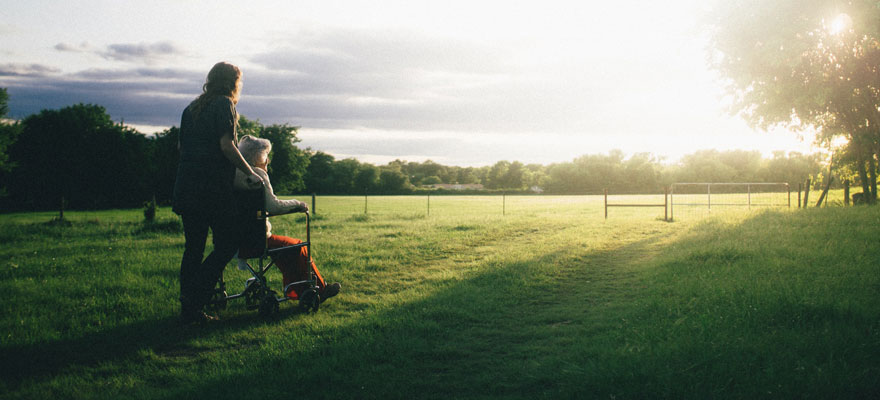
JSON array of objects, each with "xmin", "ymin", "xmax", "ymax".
[{"xmin": 180, "ymin": 211, "xmax": 238, "ymax": 308}]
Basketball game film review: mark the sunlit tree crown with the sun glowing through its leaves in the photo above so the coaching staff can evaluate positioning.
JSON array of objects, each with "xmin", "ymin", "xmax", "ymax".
[{"xmin": 710, "ymin": 0, "xmax": 880, "ymax": 201}]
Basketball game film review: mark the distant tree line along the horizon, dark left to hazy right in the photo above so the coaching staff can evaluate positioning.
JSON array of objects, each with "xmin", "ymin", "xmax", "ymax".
[{"xmin": 0, "ymin": 89, "xmax": 826, "ymax": 210}]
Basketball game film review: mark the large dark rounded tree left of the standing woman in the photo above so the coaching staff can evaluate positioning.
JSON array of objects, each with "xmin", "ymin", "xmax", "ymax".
[{"xmin": 9, "ymin": 104, "xmax": 154, "ymax": 209}]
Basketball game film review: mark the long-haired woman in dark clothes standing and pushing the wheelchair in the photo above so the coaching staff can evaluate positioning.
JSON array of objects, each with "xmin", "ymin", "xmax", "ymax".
[{"xmin": 172, "ymin": 62, "xmax": 260, "ymax": 323}]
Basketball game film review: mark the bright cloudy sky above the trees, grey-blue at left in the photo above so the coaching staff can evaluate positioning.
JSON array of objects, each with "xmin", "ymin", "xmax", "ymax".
[{"xmin": 0, "ymin": 0, "xmax": 816, "ymax": 166}]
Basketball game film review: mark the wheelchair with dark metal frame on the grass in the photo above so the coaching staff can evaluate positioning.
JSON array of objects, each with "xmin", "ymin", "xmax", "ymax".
[{"xmin": 208, "ymin": 185, "xmax": 321, "ymax": 317}]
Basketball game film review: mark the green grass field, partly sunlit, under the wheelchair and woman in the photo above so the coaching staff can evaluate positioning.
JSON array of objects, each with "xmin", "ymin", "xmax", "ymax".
[{"xmin": 0, "ymin": 194, "xmax": 880, "ymax": 399}]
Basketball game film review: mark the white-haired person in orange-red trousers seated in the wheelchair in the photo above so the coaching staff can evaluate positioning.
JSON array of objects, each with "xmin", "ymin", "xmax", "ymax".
[{"xmin": 234, "ymin": 135, "xmax": 341, "ymax": 301}]
